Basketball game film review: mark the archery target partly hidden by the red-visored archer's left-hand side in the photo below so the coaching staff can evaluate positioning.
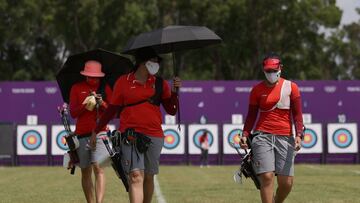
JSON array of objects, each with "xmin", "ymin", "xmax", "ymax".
[{"xmin": 223, "ymin": 124, "xmax": 245, "ymax": 154}]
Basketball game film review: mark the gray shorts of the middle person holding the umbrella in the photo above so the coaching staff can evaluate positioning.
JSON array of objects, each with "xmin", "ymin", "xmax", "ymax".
[{"xmin": 121, "ymin": 136, "xmax": 164, "ymax": 174}]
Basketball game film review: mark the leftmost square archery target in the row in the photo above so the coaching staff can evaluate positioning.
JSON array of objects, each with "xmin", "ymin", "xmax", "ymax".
[{"xmin": 17, "ymin": 125, "xmax": 46, "ymax": 155}]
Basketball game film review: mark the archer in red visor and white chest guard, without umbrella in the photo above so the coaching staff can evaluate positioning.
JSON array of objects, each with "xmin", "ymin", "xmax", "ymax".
[{"xmin": 240, "ymin": 53, "xmax": 304, "ymax": 203}]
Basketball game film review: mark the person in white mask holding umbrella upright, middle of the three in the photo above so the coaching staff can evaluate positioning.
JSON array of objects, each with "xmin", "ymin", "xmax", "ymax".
[{"xmin": 91, "ymin": 47, "xmax": 181, "ymax": 202}]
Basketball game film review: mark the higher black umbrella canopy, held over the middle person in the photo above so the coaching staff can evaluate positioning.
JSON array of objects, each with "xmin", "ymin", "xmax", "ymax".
[{"xmin": 122, "ymin": 26, "xmax": 222, "ymax": 54}]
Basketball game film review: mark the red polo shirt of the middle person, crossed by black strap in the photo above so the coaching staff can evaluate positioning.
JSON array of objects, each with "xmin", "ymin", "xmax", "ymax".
[{"xmin": 111, "ymin": 73, "xmax": 171, "ymax": 137}]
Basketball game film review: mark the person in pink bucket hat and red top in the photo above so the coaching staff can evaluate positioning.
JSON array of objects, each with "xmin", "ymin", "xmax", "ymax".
[{"xmin": 69, "ymin": 60, "xmax": 112, "ymax": 202}]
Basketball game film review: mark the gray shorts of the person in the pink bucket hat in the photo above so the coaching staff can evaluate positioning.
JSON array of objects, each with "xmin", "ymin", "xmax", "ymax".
[{"xmin": 76, "ymin": 132, "xmax": 109, "ymax": 168}]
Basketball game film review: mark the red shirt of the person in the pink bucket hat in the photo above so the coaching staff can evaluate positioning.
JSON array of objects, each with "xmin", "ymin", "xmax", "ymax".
[{"xmin": 69, "ymin": 81, "xmax": 112, "ymax": 135}]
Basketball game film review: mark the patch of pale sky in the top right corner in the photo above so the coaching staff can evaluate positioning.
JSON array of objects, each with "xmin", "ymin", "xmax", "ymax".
[{"xmin": 336, "ymin": 0, "xmax": 360, "ymax": 24}]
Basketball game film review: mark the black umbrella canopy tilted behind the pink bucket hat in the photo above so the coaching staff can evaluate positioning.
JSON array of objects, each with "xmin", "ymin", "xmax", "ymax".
[{"xmin": 56, "ymin": 49, "xmax": 133, "ymax": 103}]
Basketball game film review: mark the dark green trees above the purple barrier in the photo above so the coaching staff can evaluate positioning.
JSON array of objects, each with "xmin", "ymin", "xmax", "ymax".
[{"xmin": 0, "ymin": 0, "xmax": 360, "ymax": 81}]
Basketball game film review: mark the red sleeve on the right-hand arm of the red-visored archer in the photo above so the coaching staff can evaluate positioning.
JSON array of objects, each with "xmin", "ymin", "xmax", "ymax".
[{"xmin": 290, "ymin": 82, "xmax": 304, "ymax": 135}]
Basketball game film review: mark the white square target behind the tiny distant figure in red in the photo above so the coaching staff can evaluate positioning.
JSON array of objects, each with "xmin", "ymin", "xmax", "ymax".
[{"xmin": 188, "ymin": 124, "xmax": 219, "ymax": 154}]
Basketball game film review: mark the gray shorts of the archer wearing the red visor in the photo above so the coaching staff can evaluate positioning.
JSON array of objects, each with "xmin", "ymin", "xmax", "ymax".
[{"xmin": 251, "ymin": 134, "xmax": 296, "ymax": 176}]
